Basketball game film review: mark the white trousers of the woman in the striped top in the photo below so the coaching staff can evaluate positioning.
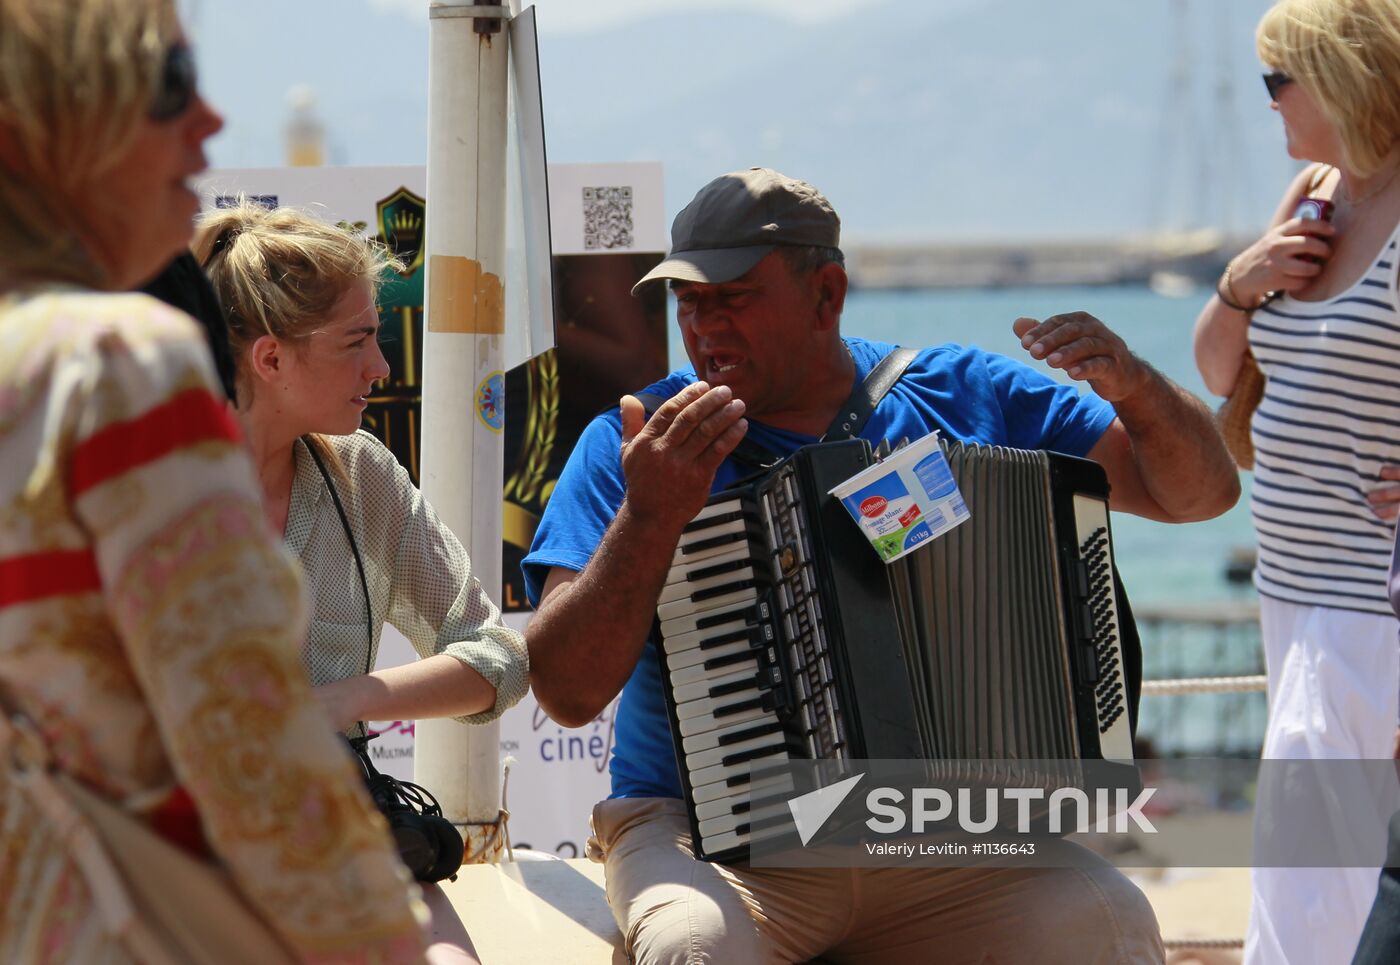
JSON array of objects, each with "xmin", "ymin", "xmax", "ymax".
[{"xmin": 1245, "ymin": 597, "xmax": 1400, "ymax": 965}]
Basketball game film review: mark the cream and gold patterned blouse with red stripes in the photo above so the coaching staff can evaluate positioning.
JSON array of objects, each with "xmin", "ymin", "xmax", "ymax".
[{"xmin": 0, "ymin": 290, "xmax": 426, "ymax": 962}]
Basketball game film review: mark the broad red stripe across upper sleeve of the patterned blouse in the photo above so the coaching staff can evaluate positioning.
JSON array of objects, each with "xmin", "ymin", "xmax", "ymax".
[{"xmin": 69, "ymin": 388, "xmax": 239, "ymax": 499}]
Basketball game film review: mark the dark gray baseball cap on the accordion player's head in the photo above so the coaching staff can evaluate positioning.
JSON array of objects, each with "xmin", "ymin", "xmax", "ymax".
[{"xmin": 631, "ymin": 168, "xmax": 841, "ymax": 294}]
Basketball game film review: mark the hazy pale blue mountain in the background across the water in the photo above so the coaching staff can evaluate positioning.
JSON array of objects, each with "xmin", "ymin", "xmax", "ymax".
[{"xmin": 196, "ymin": 0, "xmax": 1292, "ymax": 239}]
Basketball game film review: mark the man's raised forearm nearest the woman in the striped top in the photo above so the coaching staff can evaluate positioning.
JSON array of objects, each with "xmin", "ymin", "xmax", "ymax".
[{"xmin": 1113, "ymin": 363, "xmax": 1239, "ymax": 522}]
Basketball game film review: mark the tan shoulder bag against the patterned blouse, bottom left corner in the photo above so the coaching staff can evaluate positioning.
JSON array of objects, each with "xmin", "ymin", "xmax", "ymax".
[{"xmin": 0, "ymin": 711, "xmax": 297, "ymax": 965}]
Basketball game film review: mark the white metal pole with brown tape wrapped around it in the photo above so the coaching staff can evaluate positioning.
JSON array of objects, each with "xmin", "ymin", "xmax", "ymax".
[{"xmin": 413, "ymin": 0, "xmax": 510, "ymax": 861}]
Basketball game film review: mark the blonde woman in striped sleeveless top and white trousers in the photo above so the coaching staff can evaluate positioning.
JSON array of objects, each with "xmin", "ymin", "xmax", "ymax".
[{"xmin": 1196, "ymin": 0, "xmax": 1400, "ymax": 964}]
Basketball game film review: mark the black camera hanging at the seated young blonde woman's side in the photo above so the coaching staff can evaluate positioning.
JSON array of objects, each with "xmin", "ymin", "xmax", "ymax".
[{"xmin": 346, "ymin": 737, "xmax": 466, "ymax": 882}]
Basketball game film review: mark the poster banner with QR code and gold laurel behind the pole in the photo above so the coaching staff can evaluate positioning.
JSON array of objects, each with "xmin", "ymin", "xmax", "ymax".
[{"xmin": 200, "ymin": 164, "xmax": 666, "ymax": 857}]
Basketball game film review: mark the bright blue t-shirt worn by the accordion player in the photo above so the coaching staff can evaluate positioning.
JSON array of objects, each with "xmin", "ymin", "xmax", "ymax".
[{"xmin": 521, "ymin": 338, "xmax": 1114, "ymax": 797}]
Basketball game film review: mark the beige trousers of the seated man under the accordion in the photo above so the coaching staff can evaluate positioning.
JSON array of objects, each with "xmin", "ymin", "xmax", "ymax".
[{"xmin": 588, "ymin": 797, "xmax": 1163, "ymax": 965}]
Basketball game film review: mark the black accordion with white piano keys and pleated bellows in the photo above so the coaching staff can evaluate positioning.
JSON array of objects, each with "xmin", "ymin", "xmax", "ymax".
[{"xmin": 657, "ymin": 440, "xmax": 1135, "ymax": 861}]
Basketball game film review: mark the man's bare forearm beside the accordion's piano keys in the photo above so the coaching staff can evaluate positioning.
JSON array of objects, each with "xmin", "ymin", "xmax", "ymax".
[{"xmin": 525, "ymin": 500, "xmax": 680, "ymax": 727}]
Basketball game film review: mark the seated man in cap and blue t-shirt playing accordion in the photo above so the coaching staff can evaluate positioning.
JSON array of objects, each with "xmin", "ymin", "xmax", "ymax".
[{"xmin": 524, "ymin": 168, "xmax": 1239, "ymax": 965}]
